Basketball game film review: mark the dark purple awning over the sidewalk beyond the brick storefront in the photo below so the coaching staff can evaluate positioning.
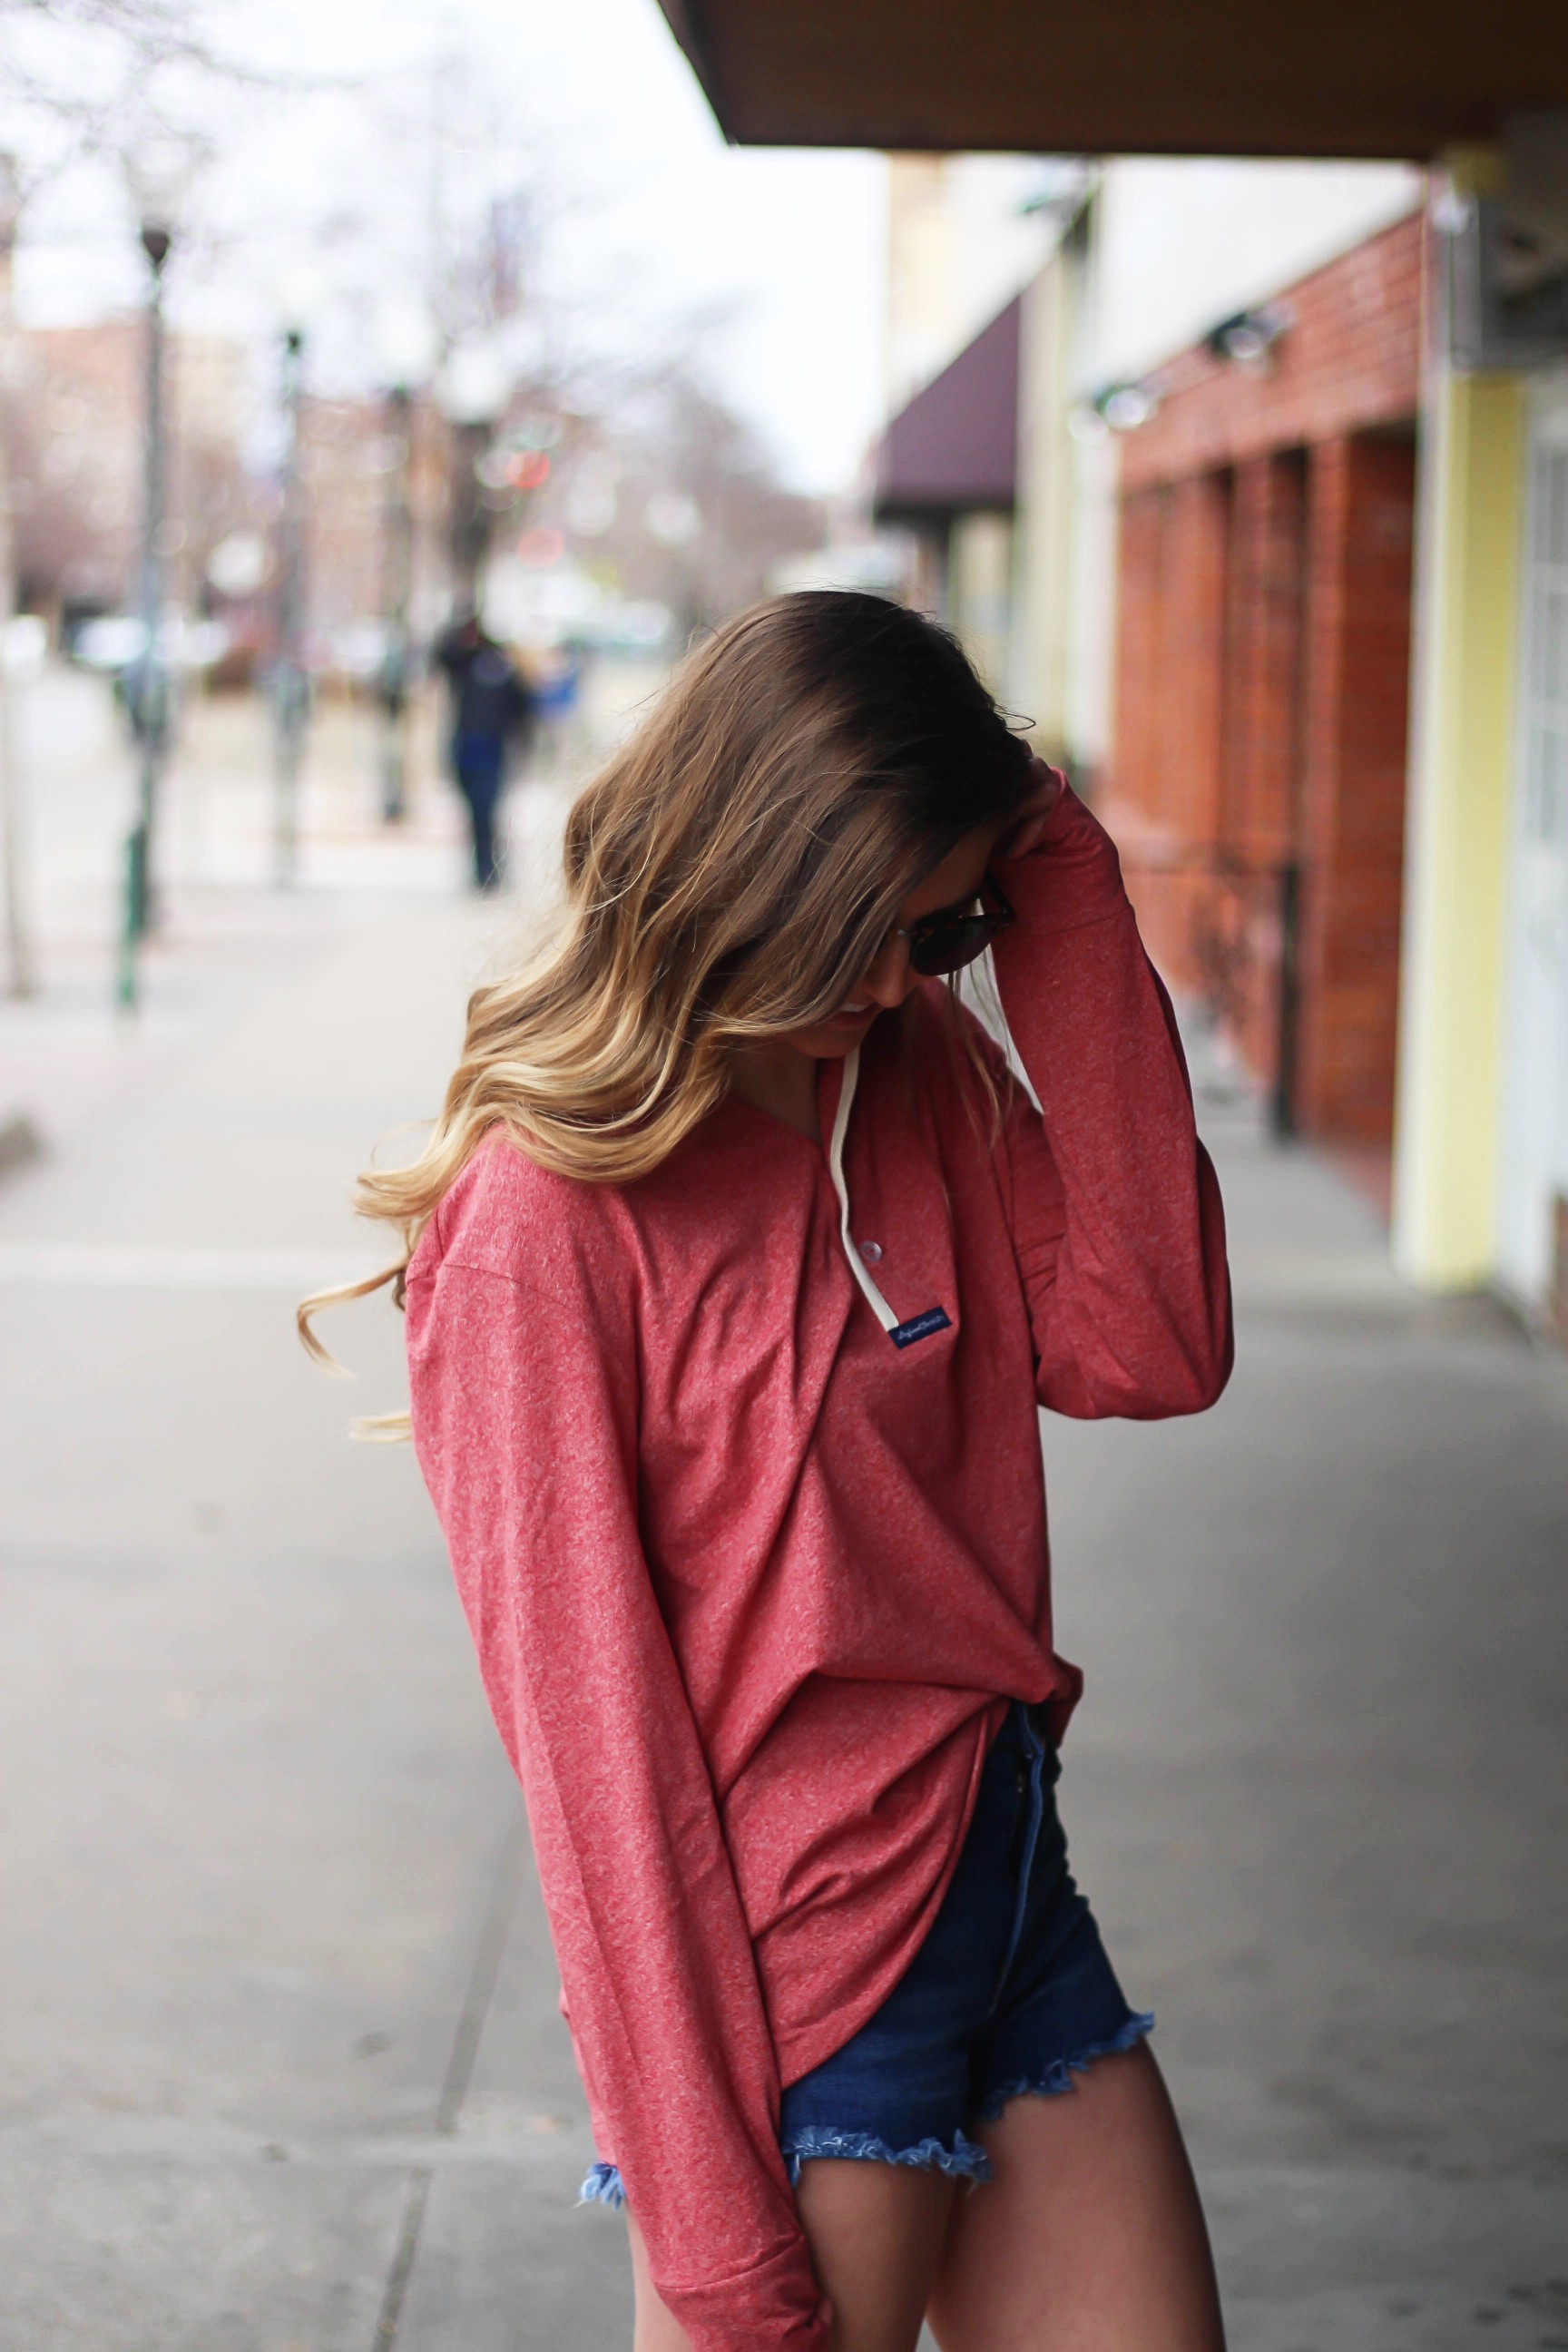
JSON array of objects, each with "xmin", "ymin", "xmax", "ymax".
[{"xmin": 875, "ymin": 299, "xmax": 1018, "ymax": 522}]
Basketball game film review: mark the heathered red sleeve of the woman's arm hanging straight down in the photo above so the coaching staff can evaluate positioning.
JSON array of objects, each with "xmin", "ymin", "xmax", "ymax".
[{"xmin": 409, "ymin": 1247, "xmax": 828, "ymax": 2352}]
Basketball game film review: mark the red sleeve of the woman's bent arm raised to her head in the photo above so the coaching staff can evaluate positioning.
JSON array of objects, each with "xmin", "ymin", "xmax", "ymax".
[{"xmin": 995, "ymin": 786, "xmax": 1234, "ymax": 1421}]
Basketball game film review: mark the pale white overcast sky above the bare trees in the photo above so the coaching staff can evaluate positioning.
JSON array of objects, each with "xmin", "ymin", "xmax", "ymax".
[{"xmin": 16, "ymin": 0, "xmax": 884, "ymax": 489}]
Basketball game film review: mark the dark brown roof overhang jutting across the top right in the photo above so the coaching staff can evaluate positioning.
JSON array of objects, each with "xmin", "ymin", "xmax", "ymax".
[{"xmin": 663, "ymin": 0, "xmax": 1568, "ymax": 158}]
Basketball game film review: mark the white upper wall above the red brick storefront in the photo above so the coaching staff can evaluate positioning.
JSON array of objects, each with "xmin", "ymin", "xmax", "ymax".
[{"xmin": 1082, "ymin": 155, "xmax": 1422, "ymax": 390}]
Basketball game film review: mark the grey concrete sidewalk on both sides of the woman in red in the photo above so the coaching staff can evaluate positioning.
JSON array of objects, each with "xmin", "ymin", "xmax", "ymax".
[{"xmin": 0, "ymin": 894, "xmax": 1568, "ymax": 2352}]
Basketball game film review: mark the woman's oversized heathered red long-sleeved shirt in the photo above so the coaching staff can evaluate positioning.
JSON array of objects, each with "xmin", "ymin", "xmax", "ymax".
[{"xmin": 409, "ymin": 793, "xmax": 1230, "ymax": 2352}]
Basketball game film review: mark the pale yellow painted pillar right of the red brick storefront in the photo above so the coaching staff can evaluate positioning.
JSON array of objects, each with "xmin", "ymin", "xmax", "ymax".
[{"xmin": 1394, "ymin": 367, "xmax": 1525, "ymax": 1291}]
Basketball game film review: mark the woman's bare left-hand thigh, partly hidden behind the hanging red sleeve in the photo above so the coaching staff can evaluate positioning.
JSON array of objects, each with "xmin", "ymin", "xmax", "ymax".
[{"xmin": 628, "ymin": 2157, "xmax": 955, "ymax": 2352}]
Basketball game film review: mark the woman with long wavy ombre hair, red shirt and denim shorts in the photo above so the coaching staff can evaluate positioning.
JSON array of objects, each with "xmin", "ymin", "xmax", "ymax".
[{"xmin": 305, "ymin": 593, "xmax": 1230, "ymax": 2352}]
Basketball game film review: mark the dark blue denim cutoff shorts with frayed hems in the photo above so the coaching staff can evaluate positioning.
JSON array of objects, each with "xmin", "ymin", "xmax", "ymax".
[{"xmin": 583, "ymin": 1700, "xmax": 1154, "ymax": 2204}]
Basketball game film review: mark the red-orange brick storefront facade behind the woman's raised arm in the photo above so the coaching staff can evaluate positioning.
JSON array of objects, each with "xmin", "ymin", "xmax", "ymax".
[{"xmin": 1102, "ymin": 216, "xmax": 1425, "ymax": 1145}]
